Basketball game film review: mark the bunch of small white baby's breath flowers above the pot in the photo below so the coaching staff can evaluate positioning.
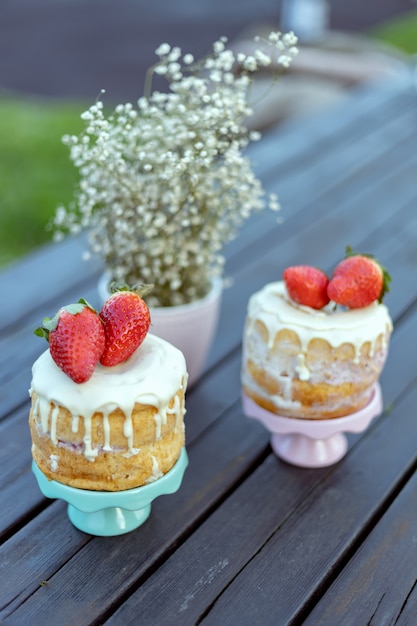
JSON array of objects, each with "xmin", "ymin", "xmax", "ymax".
[{"xmin": 53, "ymin": 32, "xmax": 297, "ymax": 306}]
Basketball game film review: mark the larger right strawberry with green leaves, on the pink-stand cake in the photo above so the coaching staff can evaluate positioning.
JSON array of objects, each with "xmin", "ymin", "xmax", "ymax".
[{"xmin": 327, "ymin": 247, "xmax": 391, "ymax": 309}]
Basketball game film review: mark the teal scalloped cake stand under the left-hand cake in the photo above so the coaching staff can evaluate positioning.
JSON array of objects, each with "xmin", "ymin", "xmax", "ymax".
[{"xmin": 32, "ymin": 448, "xmax": 188, "ymax": 537}]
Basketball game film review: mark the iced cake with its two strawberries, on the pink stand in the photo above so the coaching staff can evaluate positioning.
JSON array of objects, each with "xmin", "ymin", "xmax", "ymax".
[{"xmin": 242, "ymin": 249, "xmax": 392, "ymax": 419}]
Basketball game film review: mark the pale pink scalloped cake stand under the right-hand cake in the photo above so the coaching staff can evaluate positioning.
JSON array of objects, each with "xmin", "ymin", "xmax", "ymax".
[{"xmin": 242, "ymin": 384, "xmax": 382, "ymax": 467}]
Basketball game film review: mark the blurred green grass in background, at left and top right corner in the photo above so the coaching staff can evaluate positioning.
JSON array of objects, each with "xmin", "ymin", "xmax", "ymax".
[{"xmin": 0, "ymin": 10, "xmax": 417, "ymax": 267}]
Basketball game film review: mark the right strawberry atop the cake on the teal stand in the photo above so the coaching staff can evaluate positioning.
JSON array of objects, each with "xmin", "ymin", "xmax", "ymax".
[{"xmin": 100, "ymin": 286, "xmax": 151, "ymax": 367}]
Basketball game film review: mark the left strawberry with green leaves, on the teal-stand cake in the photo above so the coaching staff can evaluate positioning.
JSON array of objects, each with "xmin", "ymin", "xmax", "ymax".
[{"xmin": 35, "ymin": 300, "xmax": 106, "ymax": 383}]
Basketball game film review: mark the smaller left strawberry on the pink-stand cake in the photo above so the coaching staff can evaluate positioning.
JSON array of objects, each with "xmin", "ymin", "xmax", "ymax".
[{"xmin": 283, "ymin": 265, "xmax": 329, "ymax": 309}]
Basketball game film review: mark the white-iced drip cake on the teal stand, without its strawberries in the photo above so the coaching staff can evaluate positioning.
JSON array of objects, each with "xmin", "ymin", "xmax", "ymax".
[{"xmin": 29, "ymin": 334, "xmax": 187, "ymax": 491}]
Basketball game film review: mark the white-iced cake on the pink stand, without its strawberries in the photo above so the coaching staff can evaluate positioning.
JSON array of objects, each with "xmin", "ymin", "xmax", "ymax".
[{"xmin": 242, "ymin": 254, "xmax": 393, "ymax": 419}]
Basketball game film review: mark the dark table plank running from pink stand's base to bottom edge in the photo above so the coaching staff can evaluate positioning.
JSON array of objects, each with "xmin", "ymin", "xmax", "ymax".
[{"xmin": 106, "ymin": 455, "xmax": 326, "ymax": 626}]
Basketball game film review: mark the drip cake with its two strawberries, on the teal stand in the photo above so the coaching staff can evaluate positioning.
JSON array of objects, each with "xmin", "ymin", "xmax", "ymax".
[{"xmin": 29, "ymin": 289, "xmax": 187, "ymax": 491}]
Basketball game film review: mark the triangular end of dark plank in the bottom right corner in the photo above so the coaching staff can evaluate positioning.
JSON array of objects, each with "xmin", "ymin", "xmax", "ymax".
[{"xmin": 304, "ymin": 474, "xmax": 417, "ymax": 626}]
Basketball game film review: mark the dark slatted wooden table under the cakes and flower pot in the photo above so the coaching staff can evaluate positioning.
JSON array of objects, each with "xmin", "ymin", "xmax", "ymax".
[{"xmin": 0, "ymin": 70, "xmax": 417, "ymax": 626}]
